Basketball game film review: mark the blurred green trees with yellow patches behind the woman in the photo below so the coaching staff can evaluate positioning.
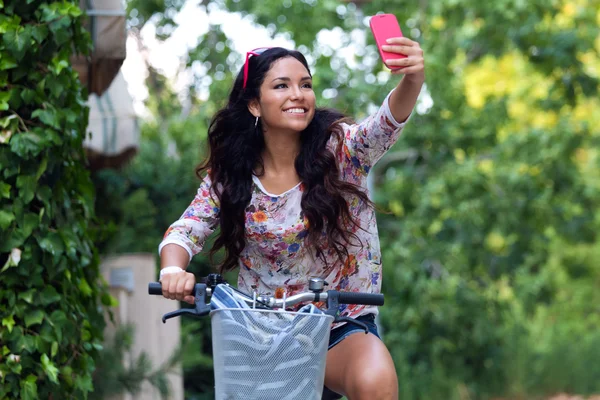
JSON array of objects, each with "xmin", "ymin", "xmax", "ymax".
[{"xmin": 94, "ymin": 0, "xmax": 600, "ymax": 400}]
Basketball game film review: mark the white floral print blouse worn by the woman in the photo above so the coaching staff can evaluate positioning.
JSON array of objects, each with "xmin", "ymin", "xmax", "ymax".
[{"xmin": 159, "ymin": 90, "xmax": 404, "ymax": 318}]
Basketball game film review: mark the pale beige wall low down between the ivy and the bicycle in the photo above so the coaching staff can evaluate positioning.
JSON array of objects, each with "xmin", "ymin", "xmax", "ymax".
[{"xmin": 101, "ymin": 253, "xmax": 184, "ymax": 400}]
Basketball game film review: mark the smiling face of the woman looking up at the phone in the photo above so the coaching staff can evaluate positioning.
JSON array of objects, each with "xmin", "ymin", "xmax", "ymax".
[{"xmin": 248, "ymin": 57, "xmax": 316, "ymax": 132}]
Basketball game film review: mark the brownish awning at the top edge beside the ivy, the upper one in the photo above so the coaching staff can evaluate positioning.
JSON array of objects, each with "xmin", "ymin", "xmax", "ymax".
[{"xmin": 71, "ymin": 0, "xmax": 127, "ymax": 95}]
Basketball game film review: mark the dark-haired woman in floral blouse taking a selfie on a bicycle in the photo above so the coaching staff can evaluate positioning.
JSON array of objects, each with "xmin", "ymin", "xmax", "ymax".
[{"xmin": 159, "ymin": 38, "xmax": 424, "ymax": 400}]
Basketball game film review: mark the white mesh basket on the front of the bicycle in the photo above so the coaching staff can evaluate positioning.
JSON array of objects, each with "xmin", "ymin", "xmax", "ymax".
[{"xmin": 210, "ymin": 308, "xmax": 333, "ymax": 400}]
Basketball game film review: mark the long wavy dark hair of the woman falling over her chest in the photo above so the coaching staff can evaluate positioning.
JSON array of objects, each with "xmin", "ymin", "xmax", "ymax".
[{"xmin": 196, "ymin": 47, "xmax": 373, "ymax": 272}]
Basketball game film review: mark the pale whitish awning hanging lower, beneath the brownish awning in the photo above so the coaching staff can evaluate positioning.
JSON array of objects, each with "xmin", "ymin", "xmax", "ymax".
[{"xmin": 83, "ymin": 72, "xmax": 139, "ymax": 170}]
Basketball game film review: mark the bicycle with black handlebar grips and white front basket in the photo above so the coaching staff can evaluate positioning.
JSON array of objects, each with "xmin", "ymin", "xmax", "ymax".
[{"xmin": 148, "ymin": 274, "xmax": 384, "ymax": 400}]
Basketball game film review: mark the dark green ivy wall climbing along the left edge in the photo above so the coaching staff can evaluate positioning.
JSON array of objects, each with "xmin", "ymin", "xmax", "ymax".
[{"xmin": 0, "ymin": 0, "xmax": 109, "ymax": 400}]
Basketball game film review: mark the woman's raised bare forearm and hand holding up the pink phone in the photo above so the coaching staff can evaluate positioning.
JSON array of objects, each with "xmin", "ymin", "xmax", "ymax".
[{"xmin": 382, "ymin": 37, "xmax": 425, "ymax": 122}]
